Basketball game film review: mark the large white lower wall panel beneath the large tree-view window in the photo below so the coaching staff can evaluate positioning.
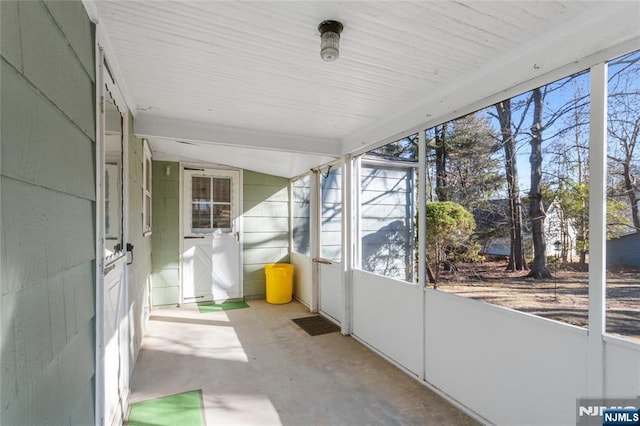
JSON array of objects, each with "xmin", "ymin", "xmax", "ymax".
[{"xmin": 425, "ymin": 289, "xmax": 587, "ymax": 425}]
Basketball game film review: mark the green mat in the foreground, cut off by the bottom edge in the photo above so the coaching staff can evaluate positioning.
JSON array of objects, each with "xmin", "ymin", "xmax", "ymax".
[{"xmin": 126, "ymin": 390, "xmax": 205, "ymax": 426}]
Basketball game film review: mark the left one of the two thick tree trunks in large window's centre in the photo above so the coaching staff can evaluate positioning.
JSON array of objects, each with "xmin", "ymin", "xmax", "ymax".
[{"xmin": 496, "ymin": 100, "xmax": 527, "ymax": 271}]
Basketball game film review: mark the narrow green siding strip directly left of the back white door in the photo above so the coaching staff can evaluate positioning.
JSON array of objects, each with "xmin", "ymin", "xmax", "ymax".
[{"xmin": 151, "ymin": 161, "xmax": 180, "ymax": 306}]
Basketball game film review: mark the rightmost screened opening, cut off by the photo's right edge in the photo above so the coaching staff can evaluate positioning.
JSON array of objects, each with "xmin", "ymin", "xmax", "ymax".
[{"xmin": 606, "ymin": 51, "xmax": 640, "ymax": 342}]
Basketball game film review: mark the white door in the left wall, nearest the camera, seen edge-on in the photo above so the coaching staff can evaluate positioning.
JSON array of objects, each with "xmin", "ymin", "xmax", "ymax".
[{"xmin": 95, "ymin": 50, "xmax": 130, "ymax": 425}]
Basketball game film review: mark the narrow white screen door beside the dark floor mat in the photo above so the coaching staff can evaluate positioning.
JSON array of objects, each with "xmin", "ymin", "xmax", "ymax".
[{"xmin": 314, "ymin": 166, "xmax": 344, "ymax": 324}]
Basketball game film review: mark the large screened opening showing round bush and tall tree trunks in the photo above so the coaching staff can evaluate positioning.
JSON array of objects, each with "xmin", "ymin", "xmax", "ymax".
[{"xmin": 425, "ymin": 67, "xmax": 591, "ymax": 327}]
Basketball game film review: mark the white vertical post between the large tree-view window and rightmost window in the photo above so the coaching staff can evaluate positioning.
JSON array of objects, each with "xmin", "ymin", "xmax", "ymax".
[{"xmin": 587, "ymin": 63, "xmax": 607, "ymax": 398}]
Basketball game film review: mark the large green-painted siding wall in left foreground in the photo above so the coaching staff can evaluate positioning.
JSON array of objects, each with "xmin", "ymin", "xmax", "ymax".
[{"xmin": 0, "ymin": 1, "xmax": 96, "ymax": 425}]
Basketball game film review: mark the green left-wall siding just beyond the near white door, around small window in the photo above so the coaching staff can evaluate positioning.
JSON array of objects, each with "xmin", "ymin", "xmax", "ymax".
[{"xmin": 127, "ymin": 121, "xmax": 153, "ymax": 370}]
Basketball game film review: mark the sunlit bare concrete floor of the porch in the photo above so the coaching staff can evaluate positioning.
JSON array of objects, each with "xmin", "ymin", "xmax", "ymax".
[{"xmin": 130, "ymin": 301, "xmax": 476, "ymax": 425}]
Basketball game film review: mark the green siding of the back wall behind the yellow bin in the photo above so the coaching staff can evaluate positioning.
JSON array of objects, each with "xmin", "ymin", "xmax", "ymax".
[{"xmin": 242, "ymin": 170, "xmax": 289, "ymax": 299}]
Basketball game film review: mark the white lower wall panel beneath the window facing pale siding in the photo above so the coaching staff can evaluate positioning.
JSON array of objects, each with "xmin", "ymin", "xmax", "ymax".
[{"xmin": 352, "ymin": 270, "xmax": 422, "ymax": 375}]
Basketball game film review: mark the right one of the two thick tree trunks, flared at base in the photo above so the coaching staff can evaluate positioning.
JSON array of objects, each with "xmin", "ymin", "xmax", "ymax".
[{"xmin": 527, "ymin": 88, "xmax": 552, "ymax": 279}]
